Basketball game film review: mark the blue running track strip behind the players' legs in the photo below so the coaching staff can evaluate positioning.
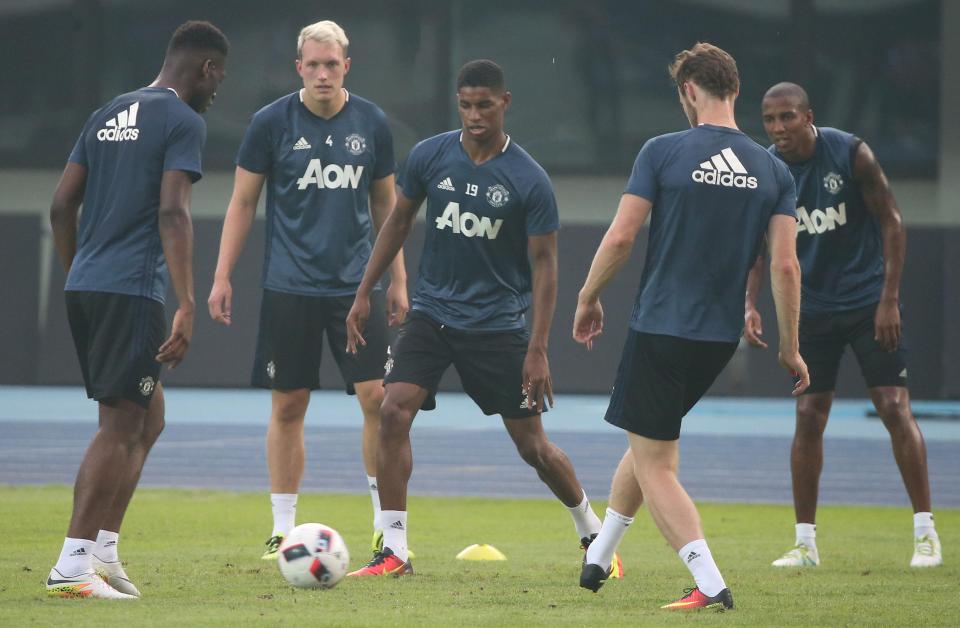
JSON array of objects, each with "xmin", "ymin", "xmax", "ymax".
[{"xmin": 0, "ymin": 386, "xmax": 960, "ymax": 510}]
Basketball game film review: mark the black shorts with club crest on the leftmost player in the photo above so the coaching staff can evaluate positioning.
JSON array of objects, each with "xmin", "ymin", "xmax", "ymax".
[{"xmin": 64, "ymin": 290, "xmax": 166, "ymax": 408}]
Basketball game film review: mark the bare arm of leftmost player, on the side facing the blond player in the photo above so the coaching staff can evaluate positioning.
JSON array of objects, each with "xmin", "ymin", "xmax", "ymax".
[{"xmin": 157, "ymin": 170, "xmax": 195, "ymax": 368}]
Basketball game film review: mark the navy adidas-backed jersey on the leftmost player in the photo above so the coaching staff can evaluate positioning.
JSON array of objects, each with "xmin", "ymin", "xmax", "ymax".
[{"xmin": 66, "ymin": 87, "xmax": 207, "ymax": 303}]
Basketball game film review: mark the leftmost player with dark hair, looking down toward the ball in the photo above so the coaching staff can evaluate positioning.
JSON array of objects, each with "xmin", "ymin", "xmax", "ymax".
[{"xmin": 47, "ymin": 22, "xmax": 229, "ymax": 599}]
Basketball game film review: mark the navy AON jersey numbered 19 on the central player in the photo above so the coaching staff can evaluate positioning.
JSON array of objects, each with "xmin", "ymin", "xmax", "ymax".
[{"xmin": 400, "ymin": 131, "xmax": 560, "ymax": 331}]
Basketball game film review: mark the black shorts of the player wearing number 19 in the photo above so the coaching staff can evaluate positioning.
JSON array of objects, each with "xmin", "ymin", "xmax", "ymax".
[{"xmin": 384, "ymin": 311, "xmax": 540, "ymax": 419}]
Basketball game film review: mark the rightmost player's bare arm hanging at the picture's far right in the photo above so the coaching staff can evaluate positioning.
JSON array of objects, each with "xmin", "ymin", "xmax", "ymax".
[{"xmin": 853, "ymin": 142, "xmax": 907, "ymax": 351}]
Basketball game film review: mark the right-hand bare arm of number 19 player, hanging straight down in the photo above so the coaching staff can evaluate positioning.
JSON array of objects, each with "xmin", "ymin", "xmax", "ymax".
[{"xmin": 523, "ymin": 231, "xmax": 557, "ymax": 410}]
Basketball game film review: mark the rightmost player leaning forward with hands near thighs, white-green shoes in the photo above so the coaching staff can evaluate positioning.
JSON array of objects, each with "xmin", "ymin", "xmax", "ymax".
[{"xmin": 744, "ymin": 83, "xmax": 943, "ymax": 567}]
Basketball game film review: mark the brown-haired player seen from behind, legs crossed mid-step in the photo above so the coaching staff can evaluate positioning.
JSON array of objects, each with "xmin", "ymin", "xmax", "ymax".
[{"xmin": 573, "ymin": 43, "xmax": 808, "ymax": 610}]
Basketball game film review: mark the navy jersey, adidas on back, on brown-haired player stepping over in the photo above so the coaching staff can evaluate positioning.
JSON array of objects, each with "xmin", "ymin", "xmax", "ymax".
[{"xmin": 625, "ymin": 124, "xmax": 796, "ymax": 342}]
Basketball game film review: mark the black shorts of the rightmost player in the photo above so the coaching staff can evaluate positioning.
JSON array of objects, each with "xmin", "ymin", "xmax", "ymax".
[{"xmin": 800, "ymin": 304, "xmax": 907, "ymax": 394}]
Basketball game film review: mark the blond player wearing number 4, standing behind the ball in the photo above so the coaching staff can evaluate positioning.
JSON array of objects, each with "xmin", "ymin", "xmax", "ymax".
[{"xmin": 208, "ymin": 21, "xmax": 409, "ymax": 560}]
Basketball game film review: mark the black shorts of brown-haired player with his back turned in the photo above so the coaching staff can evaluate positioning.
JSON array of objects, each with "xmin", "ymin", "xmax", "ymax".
[{"xmin": 604, "ymin": 329, "xmax": 737, "ymax": 440}]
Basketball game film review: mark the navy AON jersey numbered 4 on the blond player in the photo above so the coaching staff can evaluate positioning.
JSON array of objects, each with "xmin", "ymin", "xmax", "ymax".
[{"xmin": 237, "ymin": 91, "xmax": 396, "ymax": 296}]
